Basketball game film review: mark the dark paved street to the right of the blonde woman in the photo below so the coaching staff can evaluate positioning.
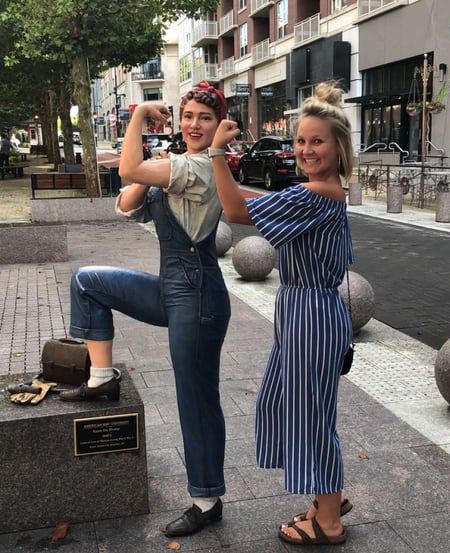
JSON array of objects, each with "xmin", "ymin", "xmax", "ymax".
[{"xmin": 350, "ymin": 214, "xmax": 450, "ymax": 349}]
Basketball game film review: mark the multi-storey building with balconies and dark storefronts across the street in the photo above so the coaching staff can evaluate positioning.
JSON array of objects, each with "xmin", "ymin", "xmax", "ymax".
[{"xmin": 183, "ymin": 0, "xmax": 450, "ymax": 159}]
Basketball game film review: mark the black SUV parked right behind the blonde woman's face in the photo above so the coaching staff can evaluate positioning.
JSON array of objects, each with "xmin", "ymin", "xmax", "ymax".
[{"xmin": 239, "ymin": 136, "xmax": 308, "ymax": 190}]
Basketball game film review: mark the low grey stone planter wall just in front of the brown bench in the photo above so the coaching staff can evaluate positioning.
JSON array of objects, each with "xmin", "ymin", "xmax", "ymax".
[{"xmin": 31, "ymin": 196, "xmax": 118, "ymax": 223}]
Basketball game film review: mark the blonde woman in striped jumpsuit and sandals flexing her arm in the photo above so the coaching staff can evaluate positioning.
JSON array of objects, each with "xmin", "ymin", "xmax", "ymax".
[{"xmin": 207, "ymin": 82, "xmax": 353, "ymax": 545}]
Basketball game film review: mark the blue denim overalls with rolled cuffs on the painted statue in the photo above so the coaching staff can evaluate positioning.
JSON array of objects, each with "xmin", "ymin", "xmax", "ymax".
[{"xmin": 70, "ymin": 189, "xmax": 230, "ymax": 497}]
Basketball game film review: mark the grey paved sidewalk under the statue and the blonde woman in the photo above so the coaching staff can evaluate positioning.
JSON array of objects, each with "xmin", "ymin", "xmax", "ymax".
[{"xmin": 0, "ymin": 222, "xmax": 450, "ymax": 553}]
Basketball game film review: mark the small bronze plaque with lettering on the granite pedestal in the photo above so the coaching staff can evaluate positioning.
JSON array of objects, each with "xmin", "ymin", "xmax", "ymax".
[{"xmin": 73, "ymin": 413, "xmax": 139, "ymax": 457}]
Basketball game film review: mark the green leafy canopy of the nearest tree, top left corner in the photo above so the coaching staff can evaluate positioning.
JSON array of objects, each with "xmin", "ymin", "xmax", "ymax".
[{"xmin": 0, "ymin": 0, "xmax": 218, "ymax": 67}]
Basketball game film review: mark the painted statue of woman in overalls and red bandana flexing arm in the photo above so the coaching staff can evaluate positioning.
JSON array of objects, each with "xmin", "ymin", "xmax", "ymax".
[{"xmin": 60, "ymin": 81, "xmax": 230, "ymax": 536}]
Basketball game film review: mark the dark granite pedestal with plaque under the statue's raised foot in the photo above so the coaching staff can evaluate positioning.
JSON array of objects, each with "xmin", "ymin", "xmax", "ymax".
[{"xmin": 0, "ymin": 368, "xmax": 149, "ymax": 533}]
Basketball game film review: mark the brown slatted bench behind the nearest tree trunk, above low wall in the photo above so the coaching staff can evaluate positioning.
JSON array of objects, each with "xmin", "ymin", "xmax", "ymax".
[{"xmin": 31, "ymin": 171, "xmax": 114, "ymax": 199}]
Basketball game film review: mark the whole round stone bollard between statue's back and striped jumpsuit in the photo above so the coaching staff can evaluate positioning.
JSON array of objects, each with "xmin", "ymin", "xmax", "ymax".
[{"xmin": 231, "ymin": 236, "xmax": 277, "ymax": 280}]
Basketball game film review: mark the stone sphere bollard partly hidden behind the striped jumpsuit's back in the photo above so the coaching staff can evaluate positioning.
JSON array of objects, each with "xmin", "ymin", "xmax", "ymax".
[{"xmin": 338, "ymin": 271, "xmax": 375, "ymax": 333}]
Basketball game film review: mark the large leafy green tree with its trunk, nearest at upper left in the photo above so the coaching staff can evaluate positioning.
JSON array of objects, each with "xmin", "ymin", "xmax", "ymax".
[{"xmin": 0, "ymin": 0, "xmax": 218, "ymax": 197}]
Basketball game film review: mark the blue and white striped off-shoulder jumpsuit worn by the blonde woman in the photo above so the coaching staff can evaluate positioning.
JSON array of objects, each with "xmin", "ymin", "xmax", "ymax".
[{"xmin": 247, "ymin": 185, "xmax": 353, "ymax": 494}]
